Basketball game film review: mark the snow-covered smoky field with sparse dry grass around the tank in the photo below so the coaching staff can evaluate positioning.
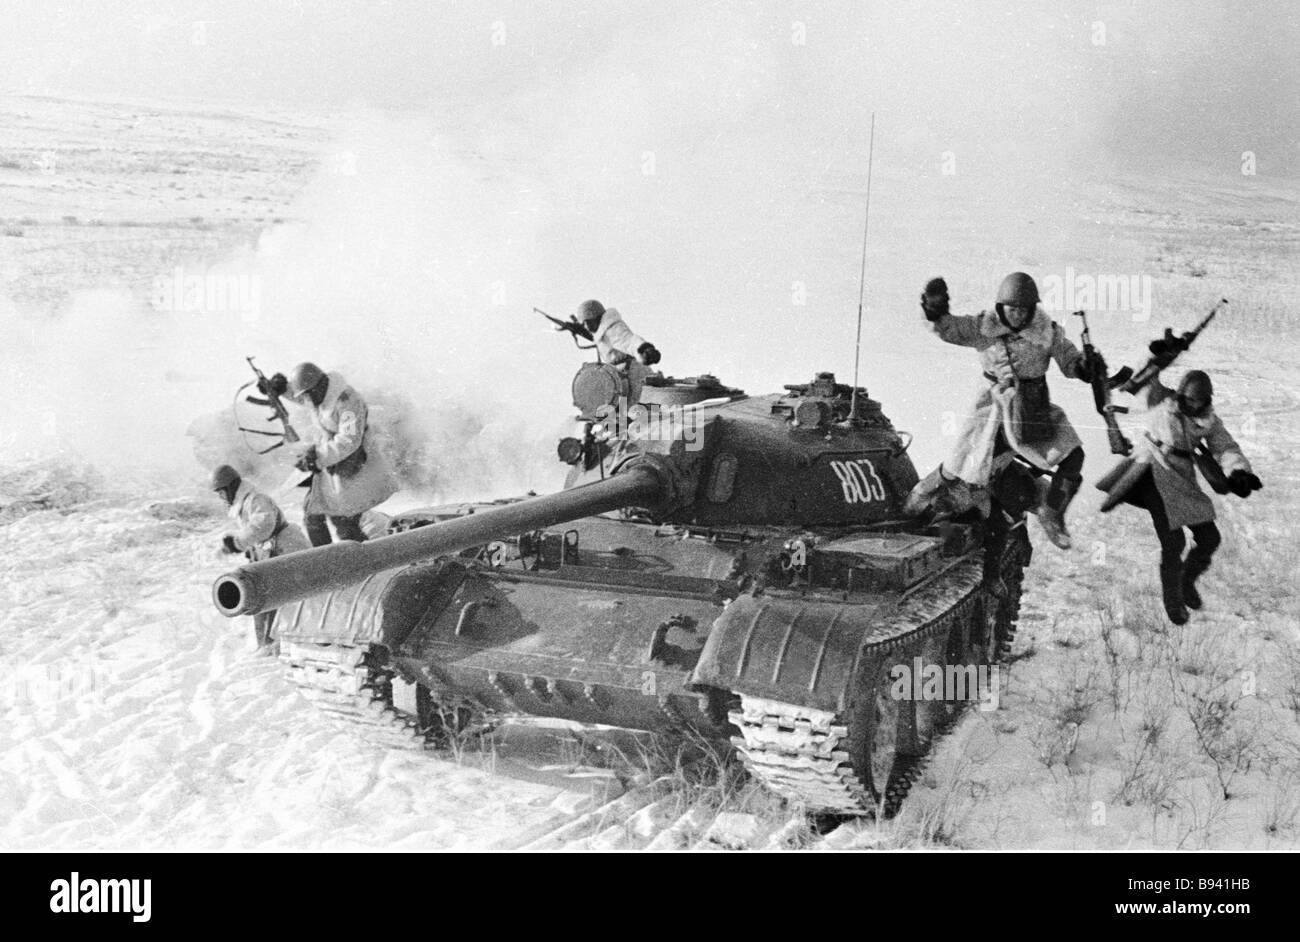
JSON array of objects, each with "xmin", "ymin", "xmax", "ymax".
[{"xmin": 0, "ymin": 96, "xmax": 1300, "ymax": 848}]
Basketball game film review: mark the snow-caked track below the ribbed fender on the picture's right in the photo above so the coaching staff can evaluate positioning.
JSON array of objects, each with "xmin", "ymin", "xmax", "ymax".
[{"xmin": 729, "ymin": 539, "xmax": 1024, "ymax": 817}]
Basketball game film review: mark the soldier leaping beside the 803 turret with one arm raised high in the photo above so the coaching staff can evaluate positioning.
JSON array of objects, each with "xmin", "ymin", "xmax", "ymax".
[{"xmin": 910, "ymin": 272, "xmax": 1106, "ymax": 550}]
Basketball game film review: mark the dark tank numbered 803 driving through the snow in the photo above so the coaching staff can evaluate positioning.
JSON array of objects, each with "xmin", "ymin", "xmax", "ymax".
[{"xmin": 213, "ymin": 364, "xmax": 1031, "ymax": 816}]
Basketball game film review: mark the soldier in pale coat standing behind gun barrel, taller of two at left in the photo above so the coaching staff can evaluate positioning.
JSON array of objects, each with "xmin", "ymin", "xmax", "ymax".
[{"xmin": 254, "ymin": 363, "xmax": 398, "ymax": 546}]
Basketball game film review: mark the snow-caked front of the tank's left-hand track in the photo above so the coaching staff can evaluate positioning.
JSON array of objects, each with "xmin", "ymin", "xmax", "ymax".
[{"xmin": 280, "ymin": 641, "xmax": 429, "ymax": 750}]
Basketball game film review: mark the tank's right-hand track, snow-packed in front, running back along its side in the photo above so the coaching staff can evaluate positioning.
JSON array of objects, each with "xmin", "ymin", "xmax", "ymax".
[{"xmin": 729, "ymin": 535, "xmax": 1024, "ymax": 817}]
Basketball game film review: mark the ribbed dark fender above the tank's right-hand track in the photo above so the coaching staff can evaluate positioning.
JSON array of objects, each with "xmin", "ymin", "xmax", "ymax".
[{"xmin": 690, "ymin": 592, "xmax": 894, "ymax": 712}]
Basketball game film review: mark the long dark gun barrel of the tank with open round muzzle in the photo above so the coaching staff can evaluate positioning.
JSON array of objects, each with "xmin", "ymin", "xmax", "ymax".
[{"xmin": 212, "ymin": 463, "xmax": 671, "ymax": 617}]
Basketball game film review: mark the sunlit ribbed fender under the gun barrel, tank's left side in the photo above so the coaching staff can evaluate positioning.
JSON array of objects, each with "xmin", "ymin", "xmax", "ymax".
[{"xmin": 276, "ymin": 559, "xmax": 468, "ymax": 650}]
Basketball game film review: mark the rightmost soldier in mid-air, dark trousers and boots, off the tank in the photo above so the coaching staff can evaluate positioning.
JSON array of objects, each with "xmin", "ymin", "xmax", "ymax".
[{"xmin": 1097, "ymin": 366, "xmax": 1264, "ymax": 625}]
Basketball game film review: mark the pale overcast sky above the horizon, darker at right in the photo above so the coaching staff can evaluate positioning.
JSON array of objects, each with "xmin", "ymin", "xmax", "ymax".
[{"xmin": 0, "ymin": 0, "xmax": 1300, "ymax": 175}]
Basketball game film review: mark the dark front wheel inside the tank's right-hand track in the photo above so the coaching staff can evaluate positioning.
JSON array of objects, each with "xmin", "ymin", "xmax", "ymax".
[{"xmin": 849, "ymin": 657, "xmax": 924, "ymax": 817}]
